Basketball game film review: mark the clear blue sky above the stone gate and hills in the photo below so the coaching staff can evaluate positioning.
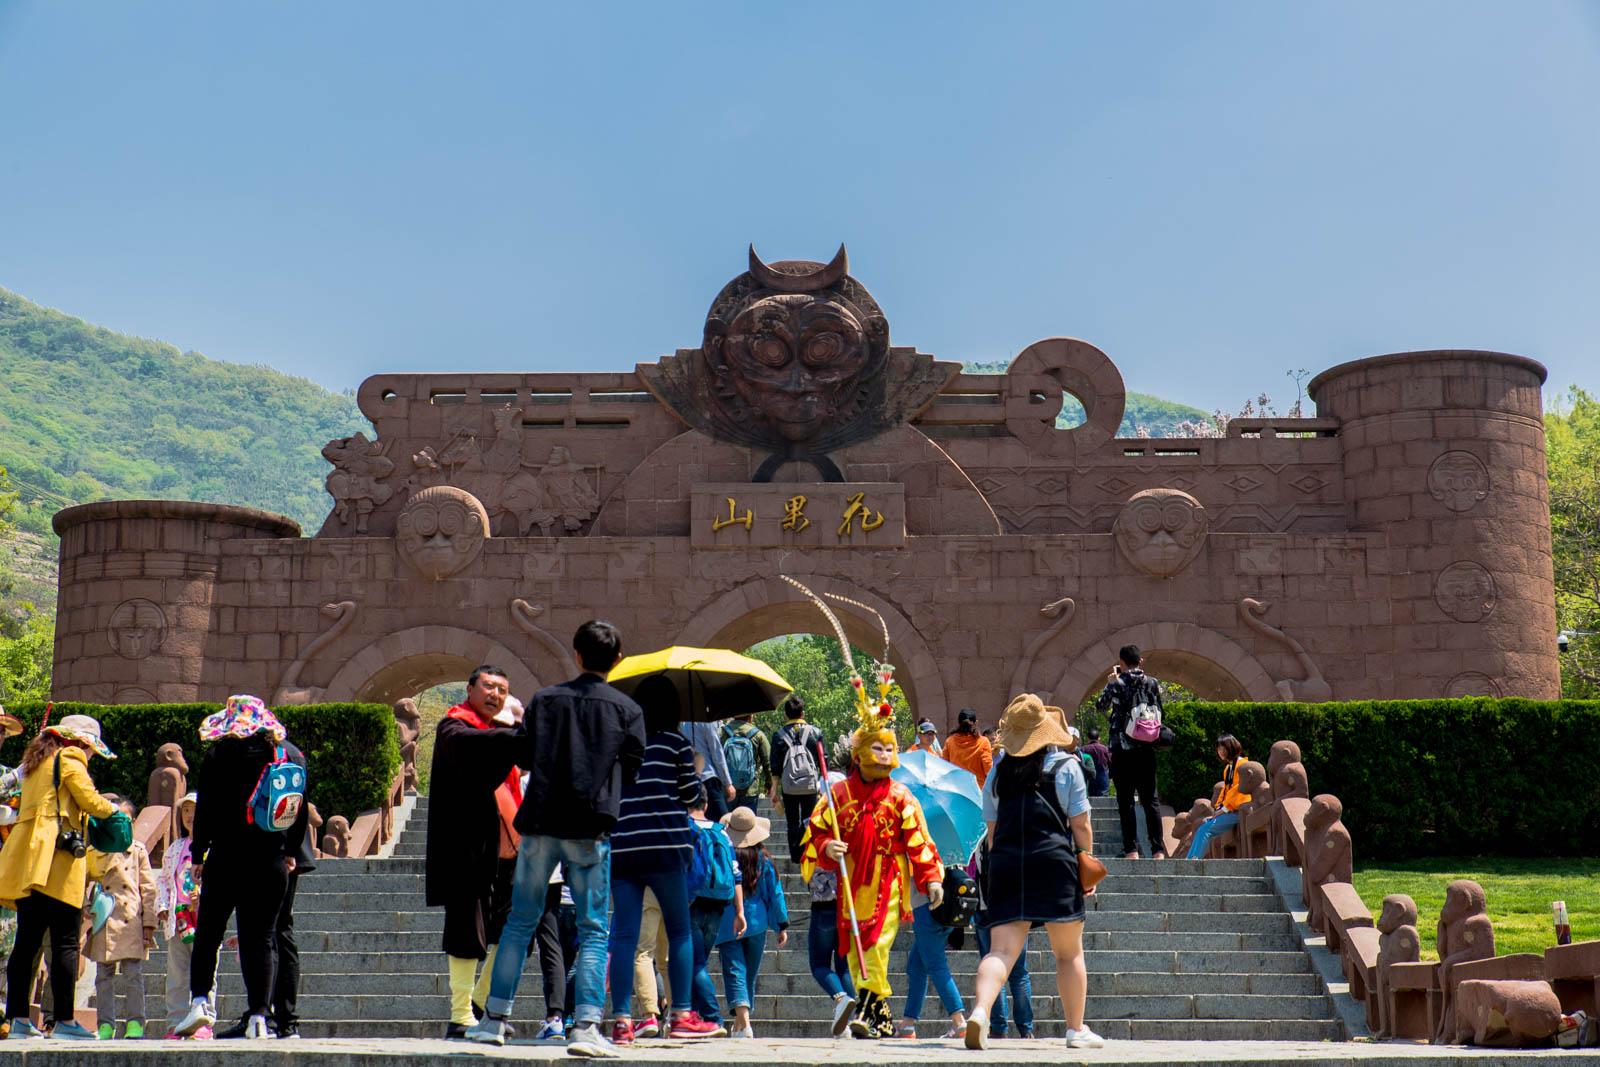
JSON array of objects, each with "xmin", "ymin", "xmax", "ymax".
[{"xmin": 0, "ymin": 0, "xmax": 1600, "ymax": 408}]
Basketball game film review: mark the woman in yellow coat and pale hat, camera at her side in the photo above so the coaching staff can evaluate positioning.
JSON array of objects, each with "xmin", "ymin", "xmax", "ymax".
[{"xmin": 0, "ymin": 715, "xmax": 115, "ymax": 1041}]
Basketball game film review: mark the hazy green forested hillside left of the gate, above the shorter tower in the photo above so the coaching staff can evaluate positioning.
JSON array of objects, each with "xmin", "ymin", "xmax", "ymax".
[{"xmin": 0, "ymin": 290, "xmax": 366, "ymax": 537}]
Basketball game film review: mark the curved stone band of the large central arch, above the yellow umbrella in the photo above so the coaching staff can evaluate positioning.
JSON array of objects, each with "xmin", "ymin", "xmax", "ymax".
[{"xmin": 674, "ymin": 574, "xmax": 952, "ymax": 729}]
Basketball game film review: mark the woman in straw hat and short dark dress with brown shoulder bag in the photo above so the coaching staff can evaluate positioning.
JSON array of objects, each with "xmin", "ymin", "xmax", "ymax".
[{"xmin": 966, "ymin": 693, "xmax": 1104, "ymax": 1049}]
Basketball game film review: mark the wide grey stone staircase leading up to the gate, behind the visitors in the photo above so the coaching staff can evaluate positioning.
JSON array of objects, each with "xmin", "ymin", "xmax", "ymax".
[{"xmin": 146, "ymin": 797, "xmax": 1346, "ymax": 1041}]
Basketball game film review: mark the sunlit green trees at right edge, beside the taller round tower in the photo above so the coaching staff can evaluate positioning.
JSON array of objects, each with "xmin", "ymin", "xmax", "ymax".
[{"xmin": 1544, "ymin": 386, "xmax": 1600, "ymax": 697}]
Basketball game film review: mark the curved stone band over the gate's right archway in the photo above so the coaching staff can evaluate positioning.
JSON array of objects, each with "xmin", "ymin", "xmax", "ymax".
[{"xmin": 1053, "ymin": 622, "xmax": 1283, "ymax": 715}]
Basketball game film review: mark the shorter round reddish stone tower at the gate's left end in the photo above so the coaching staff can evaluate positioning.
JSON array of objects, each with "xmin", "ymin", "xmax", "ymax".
[{"xmin": 53, "ymin": 501, "xmax": 301, "ymax": 704}]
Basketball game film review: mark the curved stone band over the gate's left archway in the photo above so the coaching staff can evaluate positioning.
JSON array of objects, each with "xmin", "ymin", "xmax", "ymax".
[{"xmin": 318, "ymin": 625, "xmax": 541, "ymax": 704}]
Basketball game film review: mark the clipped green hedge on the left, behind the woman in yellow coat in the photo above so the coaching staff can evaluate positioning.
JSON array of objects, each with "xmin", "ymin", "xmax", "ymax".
[{"xmin": 0, "ymin": 701, "xmax": 400, "ymax": 819}]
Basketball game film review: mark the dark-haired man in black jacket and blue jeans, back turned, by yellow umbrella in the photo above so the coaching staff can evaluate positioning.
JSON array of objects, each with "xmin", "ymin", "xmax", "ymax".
[{"xmin": 467, "ymin": 619, "xmax": 645, "ymax": 1056}]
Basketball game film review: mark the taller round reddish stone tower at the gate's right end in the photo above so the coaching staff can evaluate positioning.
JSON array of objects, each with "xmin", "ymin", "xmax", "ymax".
[{"xmin": 1309, "ymin": 350, "xmax": 1560, "ymax": 697}]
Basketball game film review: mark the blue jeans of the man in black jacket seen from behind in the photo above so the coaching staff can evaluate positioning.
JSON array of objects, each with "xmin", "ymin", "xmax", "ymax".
[{"xmin": 485, "ymin": 837, "xmax": 604, "ymax": 1024}]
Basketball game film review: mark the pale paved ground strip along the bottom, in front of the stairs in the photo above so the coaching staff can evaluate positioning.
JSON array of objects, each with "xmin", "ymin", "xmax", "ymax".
[{"xmin": 0, "ymin": 1038, "xmax": 1600, "ymax": 1067}]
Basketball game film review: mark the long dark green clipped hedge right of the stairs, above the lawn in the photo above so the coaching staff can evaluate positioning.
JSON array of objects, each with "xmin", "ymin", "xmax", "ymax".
[{"xmin": 1160, "ymin": 697, "xmax": 1600, "ymax": 861}]
